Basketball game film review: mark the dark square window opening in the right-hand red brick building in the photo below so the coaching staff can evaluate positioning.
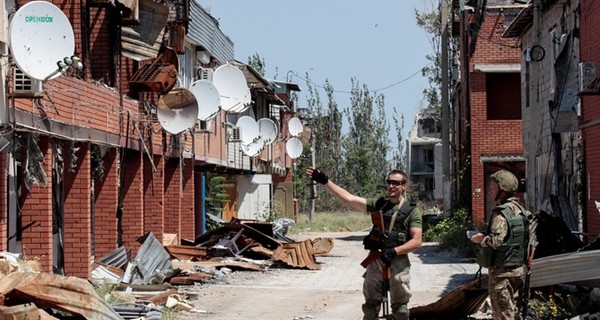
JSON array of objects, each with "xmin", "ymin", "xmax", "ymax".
[{"xmin": 486, "ymin": 73, "xmax": 521, "ymax": 120}]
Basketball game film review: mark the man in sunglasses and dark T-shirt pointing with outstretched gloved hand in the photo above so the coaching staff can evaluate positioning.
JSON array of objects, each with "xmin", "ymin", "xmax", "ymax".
[{"xmin": 306, "ymin": 167, "xmax": 423, "ymax": 320}]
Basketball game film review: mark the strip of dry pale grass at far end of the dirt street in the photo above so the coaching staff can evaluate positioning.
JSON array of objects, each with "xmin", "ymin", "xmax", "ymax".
[{"xmin": 288, "ymin": 211, "xmax": 372, "ymax": 234}]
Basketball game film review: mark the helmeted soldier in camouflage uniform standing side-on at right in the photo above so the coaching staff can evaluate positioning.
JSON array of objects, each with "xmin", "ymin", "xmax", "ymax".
[{"xmin": 471, "ymin": 170, "xmax": 529, "ymax": 320}]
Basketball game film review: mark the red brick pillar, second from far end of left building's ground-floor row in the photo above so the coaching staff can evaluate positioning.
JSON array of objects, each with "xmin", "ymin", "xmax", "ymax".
[{"xmin": 165, "ymin": 159, "xmax": 181, "ymax": 236}]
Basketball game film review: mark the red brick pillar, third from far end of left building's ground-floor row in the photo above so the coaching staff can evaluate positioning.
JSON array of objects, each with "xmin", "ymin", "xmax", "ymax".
[{"xmin": 144, "ymin": 154, "xmax": 165, "ymax": 242}]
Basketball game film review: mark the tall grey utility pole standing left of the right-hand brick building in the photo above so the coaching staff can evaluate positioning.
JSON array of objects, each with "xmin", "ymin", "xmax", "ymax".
[{"xmin": 440, "ymin": 0, "xmax": 452, "ymax": 214}]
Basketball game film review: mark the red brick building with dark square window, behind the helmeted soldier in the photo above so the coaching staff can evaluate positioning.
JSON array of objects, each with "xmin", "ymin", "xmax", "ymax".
[{"xmin": 452, "ymin": 1, "xmax": 525, "ymax": 224}]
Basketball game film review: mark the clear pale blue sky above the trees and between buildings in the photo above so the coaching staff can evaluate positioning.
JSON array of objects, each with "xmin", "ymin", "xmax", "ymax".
[{"xmin": 197, "ymin": 0, "xmax": 433, "ymax": 145}]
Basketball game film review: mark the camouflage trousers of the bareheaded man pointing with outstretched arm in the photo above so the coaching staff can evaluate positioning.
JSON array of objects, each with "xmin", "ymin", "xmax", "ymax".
[{"xmin": 363, "ymin": 254, "xmax": 412, "ymax": 320}]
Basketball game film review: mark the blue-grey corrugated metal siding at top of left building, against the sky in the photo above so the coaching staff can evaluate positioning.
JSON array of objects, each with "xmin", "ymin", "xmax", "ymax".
[{"xmin": 187, "ymin": 1, "xmax": 234, "ymax": 64}]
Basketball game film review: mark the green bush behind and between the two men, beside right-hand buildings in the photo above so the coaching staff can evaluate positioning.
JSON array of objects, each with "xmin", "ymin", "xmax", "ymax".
[{"xmin": 423, "ymin": 209, "xmax": 476, "ymax": 257}]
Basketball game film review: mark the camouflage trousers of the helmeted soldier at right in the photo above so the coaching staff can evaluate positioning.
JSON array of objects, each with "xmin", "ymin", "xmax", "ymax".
[{"xmin": 488, "ymin": 267, "xmax": 524, "ymax": 320}]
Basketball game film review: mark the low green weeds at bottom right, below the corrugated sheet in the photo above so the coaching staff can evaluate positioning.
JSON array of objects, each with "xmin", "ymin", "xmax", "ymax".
[{"xmin": 527, "ymin": 291, "xmax": 579, "ymax": 319}]
